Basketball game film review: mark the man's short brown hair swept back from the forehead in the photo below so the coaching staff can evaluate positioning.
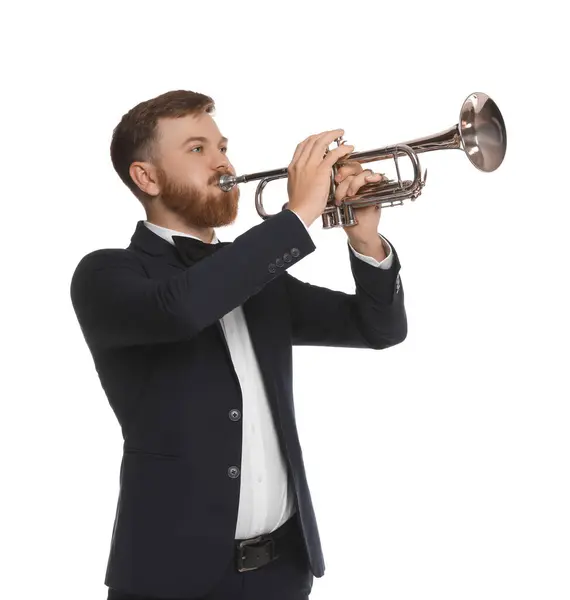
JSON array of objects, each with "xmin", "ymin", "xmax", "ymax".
[{"xmin": 111, "ymin": 90, "xmax": 215, "ymax": 202}]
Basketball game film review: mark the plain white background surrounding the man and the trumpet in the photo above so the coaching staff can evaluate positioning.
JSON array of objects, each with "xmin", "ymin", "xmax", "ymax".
[{"xmin": 0, "ymin": 0, "xmax": 570, "ymax": 600}]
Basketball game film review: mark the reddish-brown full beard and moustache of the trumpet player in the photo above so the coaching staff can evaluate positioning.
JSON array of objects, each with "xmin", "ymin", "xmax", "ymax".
[{"xmin": 157, "ymin": 167, "xmax": 239, "ymax": 228}]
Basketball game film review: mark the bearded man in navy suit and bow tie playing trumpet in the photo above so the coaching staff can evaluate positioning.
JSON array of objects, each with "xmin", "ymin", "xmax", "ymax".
[{"xmin": 71, "ymin": 91, "xmax": 407, "ymax": 600}]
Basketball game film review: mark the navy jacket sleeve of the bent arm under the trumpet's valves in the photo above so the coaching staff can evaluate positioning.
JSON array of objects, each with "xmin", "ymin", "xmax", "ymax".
[{"xmin": 284, "ymin": 233, "xmax": 407, "ymax": 350}]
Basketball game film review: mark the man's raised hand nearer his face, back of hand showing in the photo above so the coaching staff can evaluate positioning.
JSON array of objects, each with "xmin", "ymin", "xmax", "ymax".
[{"xmin": 287, "ymin": 129, "xmax": 354, "ymax": 227}]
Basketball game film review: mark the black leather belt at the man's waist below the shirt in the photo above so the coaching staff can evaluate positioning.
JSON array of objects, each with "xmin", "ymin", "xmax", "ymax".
[{"xmin": 235, "ymin": 513, "xmax": 302, "ymax": 573}]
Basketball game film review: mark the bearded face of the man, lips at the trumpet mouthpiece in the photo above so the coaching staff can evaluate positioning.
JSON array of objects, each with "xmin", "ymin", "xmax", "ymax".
[{"xmin": 150, "ymin": 113, "xmax": 239, "ymax": 228}]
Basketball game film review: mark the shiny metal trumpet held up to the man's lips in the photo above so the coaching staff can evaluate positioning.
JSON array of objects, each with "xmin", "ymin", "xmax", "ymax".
[{"xmin": 218, "ymin": 92, "xmax": 507, "ymax": 229}]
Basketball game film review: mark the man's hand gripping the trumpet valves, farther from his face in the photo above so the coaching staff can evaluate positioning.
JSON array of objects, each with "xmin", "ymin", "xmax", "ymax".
[{"xmin": 335, "ymin": 160, "xmax": 387, "ymax": 254}]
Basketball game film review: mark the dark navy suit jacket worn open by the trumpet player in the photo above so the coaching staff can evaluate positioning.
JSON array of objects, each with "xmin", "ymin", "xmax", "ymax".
[{"xmin": 70, "ymin": 210, "xmax": 407, "ymax": 597}]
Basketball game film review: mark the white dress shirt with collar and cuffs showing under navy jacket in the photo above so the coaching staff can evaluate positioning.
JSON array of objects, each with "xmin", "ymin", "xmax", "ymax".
[{"xmin": 144, "ymin": 211, "xmax": 393, "ymax": 539}]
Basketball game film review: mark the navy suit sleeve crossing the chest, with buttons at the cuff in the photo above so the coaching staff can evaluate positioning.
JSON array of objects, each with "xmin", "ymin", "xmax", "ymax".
[{"xmin": 70, "ymin": 210, "xmax": 315, "ymax": 348}]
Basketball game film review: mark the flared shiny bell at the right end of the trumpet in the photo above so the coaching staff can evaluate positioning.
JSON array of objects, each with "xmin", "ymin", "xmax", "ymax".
[{"xmin": 457, "ymin": 92, "xmax": 507, "ymax": 173}]
